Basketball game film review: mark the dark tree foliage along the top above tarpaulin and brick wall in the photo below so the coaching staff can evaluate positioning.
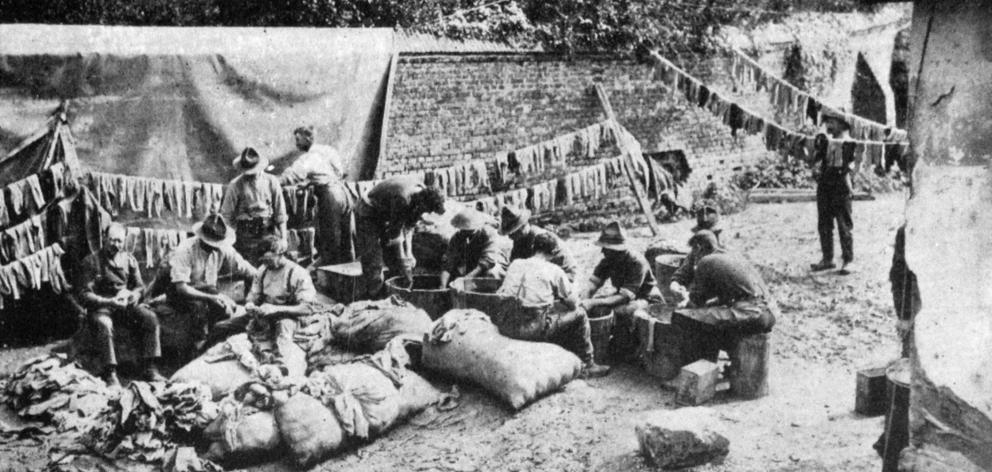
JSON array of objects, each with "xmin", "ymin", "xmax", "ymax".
[{"xmin": 0, "ymin": 0, "xmax": 859, "ymax": 57}]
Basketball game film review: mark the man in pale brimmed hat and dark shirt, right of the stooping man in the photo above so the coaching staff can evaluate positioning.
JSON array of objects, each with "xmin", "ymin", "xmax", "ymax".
[{"xmin": 441, "ymin": 208, "xmax": 507, "ymax": 287}]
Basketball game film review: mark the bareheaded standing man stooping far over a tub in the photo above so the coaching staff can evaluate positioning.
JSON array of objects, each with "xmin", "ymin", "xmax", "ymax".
[{"xmin": 355, "ymin": 176, "xmax": 444, "ymax": 299}]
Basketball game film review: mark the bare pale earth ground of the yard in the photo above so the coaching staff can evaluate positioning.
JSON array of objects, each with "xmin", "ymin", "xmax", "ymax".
[{"xmin": 0, "ymin": 193, "xmax": 904, "ymax": 472}]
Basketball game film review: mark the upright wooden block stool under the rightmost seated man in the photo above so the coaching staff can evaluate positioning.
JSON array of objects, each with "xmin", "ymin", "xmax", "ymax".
[{"xmin": 727, "ymin": 333, "xmax": 771, "ymax": 399}]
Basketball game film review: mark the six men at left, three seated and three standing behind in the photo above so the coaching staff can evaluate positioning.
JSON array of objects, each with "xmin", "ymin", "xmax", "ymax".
[{"xmin": 75, "ymin": 128, "xmax": 444, "ymax": 385}]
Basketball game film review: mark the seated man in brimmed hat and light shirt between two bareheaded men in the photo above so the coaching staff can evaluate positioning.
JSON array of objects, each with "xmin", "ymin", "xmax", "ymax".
[{"xmin": 166, "ymin": 214, "xmax": 255, "ymax": 346}]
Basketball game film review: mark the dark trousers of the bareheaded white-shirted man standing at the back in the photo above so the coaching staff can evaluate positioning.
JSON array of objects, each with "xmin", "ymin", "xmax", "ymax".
[{"xmin": 312, "ymin": 182, "xmax": 355, "ymax": 265}]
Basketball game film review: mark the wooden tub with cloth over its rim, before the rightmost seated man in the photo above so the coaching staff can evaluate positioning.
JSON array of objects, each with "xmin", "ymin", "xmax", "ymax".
[{"xmin": 634, "ymin": 303, "xmax": 682, "ymax": 380}]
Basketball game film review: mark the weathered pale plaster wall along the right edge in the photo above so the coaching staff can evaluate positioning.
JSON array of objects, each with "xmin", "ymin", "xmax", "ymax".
[{"xmin": 902, "ymin": 0, "xmax": 992, "ymax": 472}]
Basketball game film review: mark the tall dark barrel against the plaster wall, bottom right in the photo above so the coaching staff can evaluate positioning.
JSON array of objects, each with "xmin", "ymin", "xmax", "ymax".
[{"xmin": 882, "ymin": 358, "xmax": 912, "ymax": 472}]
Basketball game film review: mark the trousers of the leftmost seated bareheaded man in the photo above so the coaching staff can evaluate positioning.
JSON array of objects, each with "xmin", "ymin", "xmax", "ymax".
[{"xmin": 90, "ymin": 305, "xmax": 162, "ymax": 366}]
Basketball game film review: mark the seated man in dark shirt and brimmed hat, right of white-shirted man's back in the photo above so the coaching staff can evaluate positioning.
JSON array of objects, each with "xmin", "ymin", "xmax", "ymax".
[{"xmin": 581, "ymin": 221, "xmax": 664, "ymax": 357}]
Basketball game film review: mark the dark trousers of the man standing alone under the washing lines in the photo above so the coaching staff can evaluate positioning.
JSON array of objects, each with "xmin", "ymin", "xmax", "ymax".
[{"xmin": 816, "ymin": 171, "xmax": 854, "ymax": 262}]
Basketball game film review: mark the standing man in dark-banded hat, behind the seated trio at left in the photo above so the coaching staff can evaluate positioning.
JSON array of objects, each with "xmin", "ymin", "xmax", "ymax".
[{"xmin": 220, "ymin": 147, "xmax": 289, "ymax": 266}]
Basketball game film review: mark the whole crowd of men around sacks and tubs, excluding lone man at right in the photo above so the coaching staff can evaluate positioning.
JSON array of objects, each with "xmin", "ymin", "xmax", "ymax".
[{"xmin": 76, "ymin": 123, "xmax": 774, "ymax": 390}]
